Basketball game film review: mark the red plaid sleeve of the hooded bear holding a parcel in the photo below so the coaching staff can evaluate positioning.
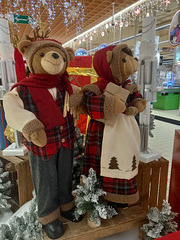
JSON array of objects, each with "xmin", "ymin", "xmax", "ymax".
[{"xmin": 84, "ymin": 91, "xmax": 105, "ymax": 119}]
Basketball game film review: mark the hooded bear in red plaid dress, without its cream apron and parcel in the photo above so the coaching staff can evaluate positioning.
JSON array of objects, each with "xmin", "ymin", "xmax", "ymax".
[{"xmin": 71, "ymin": 44, "xmax": 146, "ymax": 204}]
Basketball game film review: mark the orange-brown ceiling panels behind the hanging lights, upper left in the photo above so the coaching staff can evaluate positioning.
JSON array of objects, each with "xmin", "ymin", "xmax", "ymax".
[{"xmin": 0, "ymin": 0, "xmax": 137, "ymax": 43}]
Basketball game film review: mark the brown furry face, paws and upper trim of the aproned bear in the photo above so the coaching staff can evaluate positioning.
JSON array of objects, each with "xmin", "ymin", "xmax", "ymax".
[{"xmin": 70, "ymin": 44, "xmax": 146, "ymax": 118}]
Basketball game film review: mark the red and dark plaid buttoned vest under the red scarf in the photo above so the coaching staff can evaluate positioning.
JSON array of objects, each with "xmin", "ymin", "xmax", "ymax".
[{"xmin": 17, "ymin": 86, "xmax": 75, "ymax": 160}]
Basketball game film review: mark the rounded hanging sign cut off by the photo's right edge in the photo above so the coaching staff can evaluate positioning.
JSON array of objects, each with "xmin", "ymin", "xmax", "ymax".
[{"xmin": 169, "ymin": 9, "xmax": 180, "ymax": 47}]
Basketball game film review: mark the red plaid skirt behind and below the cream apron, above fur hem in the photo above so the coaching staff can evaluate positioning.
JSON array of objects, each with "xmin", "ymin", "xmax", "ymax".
[{"xmin": 82, "ymin": 119, "xmax": 137, "ymax": 195}]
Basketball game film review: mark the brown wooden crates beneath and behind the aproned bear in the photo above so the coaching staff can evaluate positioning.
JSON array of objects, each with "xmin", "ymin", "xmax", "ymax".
[{"xmin": 44, "ymin": 157, "xmax": 169, "ymax": 240}]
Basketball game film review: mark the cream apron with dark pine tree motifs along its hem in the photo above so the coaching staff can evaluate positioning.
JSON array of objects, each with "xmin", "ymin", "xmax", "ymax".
[{"xmin": 101, "ymin": 114, "xmax": 140, "ymax": 179}]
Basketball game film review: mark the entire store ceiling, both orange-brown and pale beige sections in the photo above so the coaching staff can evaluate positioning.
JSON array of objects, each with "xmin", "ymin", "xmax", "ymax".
[{"xmin": 0, "ymin": 0, "xmax": 179, "ymax": 59}]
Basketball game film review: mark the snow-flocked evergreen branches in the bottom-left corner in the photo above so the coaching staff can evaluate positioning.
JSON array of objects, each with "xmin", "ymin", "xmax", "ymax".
[{"xmin": 0, "ymin": 197, "xmax": 43, "ymax": 240}]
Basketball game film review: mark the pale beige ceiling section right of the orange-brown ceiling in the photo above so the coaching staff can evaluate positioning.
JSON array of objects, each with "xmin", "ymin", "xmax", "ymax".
[{"xmin": 79, "ymin": 0, "xmax": 180, "ymax": 58}]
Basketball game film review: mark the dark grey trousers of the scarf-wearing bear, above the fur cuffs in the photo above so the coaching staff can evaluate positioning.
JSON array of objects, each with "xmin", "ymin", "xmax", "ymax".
[{"xmin": 28, "ymin": 147, "xmax": 73, "ymax": 217}]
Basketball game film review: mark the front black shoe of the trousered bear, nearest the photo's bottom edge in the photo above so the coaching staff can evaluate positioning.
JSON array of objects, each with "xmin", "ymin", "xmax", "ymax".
[{"xmin": 42, "ymin": 219, "xmax": 64, "ymax": 239}]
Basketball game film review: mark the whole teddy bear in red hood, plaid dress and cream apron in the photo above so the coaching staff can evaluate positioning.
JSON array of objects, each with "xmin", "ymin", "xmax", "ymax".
[{"xmin": 70, "ymin": 44, "xmax": 146, "ymax": 209}]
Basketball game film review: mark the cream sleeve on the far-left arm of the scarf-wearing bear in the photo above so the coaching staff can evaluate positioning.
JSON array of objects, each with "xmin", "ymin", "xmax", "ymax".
[{"xmin": 3, "ymin": 88, "xmax": 37, "ymax": 132}]
